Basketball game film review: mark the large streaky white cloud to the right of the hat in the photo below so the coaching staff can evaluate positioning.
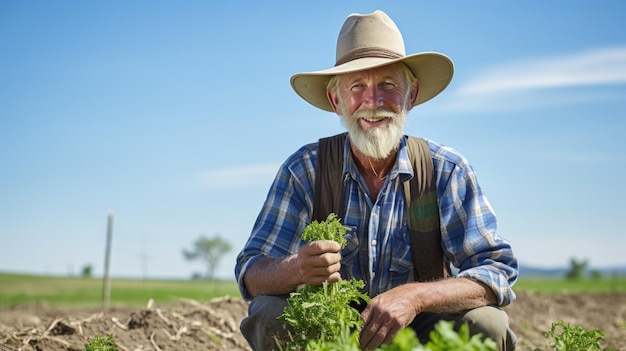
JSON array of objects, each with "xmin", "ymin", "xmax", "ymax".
[{"xmin": 438, "ymin": 47, "xmax": 626, "ymax": 111}]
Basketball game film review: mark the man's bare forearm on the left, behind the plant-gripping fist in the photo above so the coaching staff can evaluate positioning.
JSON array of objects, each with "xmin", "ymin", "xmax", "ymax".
[{"xmin": 243, "ymin": 255, "xmax": 303, "ymax": 297}]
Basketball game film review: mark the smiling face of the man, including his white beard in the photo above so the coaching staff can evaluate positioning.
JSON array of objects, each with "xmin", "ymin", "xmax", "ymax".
[{"xmin": 328, "ymin": 63, "xmax": 417, "ymax": 159}]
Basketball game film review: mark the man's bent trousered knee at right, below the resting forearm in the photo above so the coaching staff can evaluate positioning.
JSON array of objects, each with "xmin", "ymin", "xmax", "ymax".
[{"xmin": 461, "ymin": 306, "xmax": 517, "ymax": 350}]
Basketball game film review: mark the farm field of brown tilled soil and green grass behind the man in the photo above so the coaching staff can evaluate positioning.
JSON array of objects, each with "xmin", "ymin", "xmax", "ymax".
[{"xmin": 0, "ymin": 273, "xmax": 626, "ymax": 351}]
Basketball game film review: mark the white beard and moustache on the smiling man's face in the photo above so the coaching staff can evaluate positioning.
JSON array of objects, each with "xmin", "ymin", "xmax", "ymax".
[{"xmin": 341, "ymin": 109, "xmax": 407, "ymax": 160}]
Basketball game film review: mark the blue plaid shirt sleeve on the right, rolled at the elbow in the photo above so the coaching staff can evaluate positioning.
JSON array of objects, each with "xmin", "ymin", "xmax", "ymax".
[{"xmin": 431, "ymin": 142, "xmax": 519, "ymax": 306}]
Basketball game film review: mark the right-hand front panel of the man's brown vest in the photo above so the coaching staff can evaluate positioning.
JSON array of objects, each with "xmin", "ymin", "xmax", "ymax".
[{"xmin": 404, "ymin": 136, "xmax": 451, "ymax": 281}]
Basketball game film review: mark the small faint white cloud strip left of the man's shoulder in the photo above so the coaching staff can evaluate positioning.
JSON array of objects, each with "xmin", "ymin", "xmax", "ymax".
[{"xmin": 191, "ymin": 164, "xmax": 279, "ymax": 189}]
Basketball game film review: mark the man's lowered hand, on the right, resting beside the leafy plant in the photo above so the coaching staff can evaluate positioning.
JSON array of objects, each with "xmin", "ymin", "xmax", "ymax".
[{"xmin": 359, "ymin": 284, "xmax": 421, "ymax": 350}]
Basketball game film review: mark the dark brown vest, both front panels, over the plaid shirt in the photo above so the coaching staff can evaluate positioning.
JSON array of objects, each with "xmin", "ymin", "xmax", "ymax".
[{"xmin": 312, "ymin": 133, "xmax": 450, "ymax": 281}]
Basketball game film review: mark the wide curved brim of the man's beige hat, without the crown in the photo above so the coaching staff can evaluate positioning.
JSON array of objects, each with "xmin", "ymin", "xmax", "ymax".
[{"xmin": 291, "ymin": 52, "xmax": 454, "ymax": 112}]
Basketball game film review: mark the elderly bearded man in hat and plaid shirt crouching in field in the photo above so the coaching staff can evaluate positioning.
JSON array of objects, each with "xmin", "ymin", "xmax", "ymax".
[{"xmin": 235, "ymin": 11, "xmax": 518, "ymax": 350}]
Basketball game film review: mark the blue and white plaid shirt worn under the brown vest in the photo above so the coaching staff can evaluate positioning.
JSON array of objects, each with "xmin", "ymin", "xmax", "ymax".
[{"xmin": 235, "ymin": 139, "xmax": 518, "ymax": 306}]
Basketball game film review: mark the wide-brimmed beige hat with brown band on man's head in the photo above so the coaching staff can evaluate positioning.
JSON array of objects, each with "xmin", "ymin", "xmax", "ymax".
[{"xmin": 291, "ymin": 11, "xmax": 454, "ymax": 112}]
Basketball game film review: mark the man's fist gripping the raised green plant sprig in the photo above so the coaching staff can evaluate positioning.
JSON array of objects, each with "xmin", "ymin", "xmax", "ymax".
[{"xmin": 296, "ymin": 240, "xmax": 341, "ymax": 285}]
